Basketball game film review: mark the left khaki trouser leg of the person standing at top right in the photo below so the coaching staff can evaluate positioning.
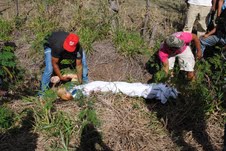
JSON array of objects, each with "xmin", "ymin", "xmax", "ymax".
[{"xmin": 183, "ymin": 4, "xmax": 199, "ymax": 32}]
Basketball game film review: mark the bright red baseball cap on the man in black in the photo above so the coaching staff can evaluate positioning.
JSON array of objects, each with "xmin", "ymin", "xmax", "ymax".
[{"xmin": 63, "ymin": 34, "xmax": 79, "ymax": 52}]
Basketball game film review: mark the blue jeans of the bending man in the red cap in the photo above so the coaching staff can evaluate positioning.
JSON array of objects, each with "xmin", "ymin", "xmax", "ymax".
[{"xmin": 41, "ymin": 47, "xmax": 89, "ymax": 95}]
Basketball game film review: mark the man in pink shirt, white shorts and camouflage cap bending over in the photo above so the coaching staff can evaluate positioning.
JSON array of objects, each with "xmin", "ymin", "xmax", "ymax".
[{"xmin": 158, "ymin": 32, "xmax": 202, "ymax": 80}]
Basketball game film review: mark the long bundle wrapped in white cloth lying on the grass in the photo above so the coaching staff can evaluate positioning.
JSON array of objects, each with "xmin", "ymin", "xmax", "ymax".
[{"xmin": 69, "ymin": 81, "xmax": 178, "ymax": 104}]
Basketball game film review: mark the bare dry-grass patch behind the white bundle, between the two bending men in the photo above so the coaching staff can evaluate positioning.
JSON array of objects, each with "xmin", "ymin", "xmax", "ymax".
[{"xmin": 87, "ymin": 40, "xmax": 150, "ymax": 83}]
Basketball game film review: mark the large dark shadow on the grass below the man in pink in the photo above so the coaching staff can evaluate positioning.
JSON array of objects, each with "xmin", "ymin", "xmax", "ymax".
[{"xmin": 147, "ymin": 93, "xmax": 215, "ymax": 151}]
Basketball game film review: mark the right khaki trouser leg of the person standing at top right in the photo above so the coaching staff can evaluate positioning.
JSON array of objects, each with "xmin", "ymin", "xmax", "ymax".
[{"xmin": 197, "ymin": 6, "xmax": 211, "ymax": 37}]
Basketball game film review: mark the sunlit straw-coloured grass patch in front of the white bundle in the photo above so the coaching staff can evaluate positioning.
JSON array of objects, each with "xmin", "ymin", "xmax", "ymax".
[{"xmin": 96, "ymin": 95, "xmax": 174, "ymax": 151}]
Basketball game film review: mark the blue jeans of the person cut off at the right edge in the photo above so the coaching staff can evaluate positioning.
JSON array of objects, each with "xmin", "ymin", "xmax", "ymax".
[{"xmin": 200, "ymin": 35, "xmax": 226, "ymax": 54}]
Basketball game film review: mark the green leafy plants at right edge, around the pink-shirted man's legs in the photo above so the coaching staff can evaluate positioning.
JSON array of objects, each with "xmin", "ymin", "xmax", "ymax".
[{"xmin": 151, "ymin": 47, "xmax": 226, "ymax": 113}]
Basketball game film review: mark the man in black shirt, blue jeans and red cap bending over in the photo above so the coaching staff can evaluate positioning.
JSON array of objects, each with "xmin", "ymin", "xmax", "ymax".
[{"xmin": 39, "ymin": 31, "xmax": 88, "ymax": 96}]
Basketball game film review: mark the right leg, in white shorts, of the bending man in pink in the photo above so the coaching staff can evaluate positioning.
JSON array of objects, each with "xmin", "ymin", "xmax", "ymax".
[{"xmin": 177, "ymin": 46, "xmax": 195, "ymax": 80}]
